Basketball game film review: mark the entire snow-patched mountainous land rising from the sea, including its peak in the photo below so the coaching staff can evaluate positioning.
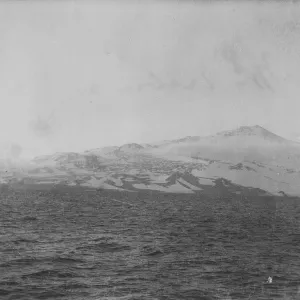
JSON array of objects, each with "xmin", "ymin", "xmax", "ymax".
[{"xmin": 1, "ymin": 126, "xmax": 300, "ymax": 195}]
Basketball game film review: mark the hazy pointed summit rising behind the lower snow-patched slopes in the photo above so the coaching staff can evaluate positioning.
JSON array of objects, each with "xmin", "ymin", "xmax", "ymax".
[{"xmin": 148, "ymin": 126, "xmax": 300, "ymax": 167}]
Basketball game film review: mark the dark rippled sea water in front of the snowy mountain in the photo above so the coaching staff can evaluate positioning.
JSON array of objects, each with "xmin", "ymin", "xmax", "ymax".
[{"xmin": 0, "ymin": 191, "xmax": 300, "ymax": 300}]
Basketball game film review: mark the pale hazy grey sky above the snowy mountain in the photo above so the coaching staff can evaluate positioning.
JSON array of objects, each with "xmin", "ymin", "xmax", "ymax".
[{"xmin": 0, "ymin": 0, "xmax": 300, "ymax": 157}]
